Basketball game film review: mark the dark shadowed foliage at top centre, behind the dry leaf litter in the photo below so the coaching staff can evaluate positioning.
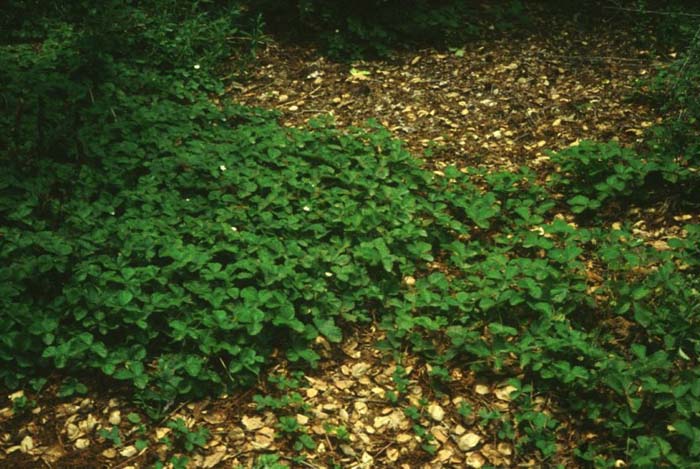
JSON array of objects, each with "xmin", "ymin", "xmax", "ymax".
[{"xmin": 251, "ymin": 0, "xmax": 528, "ymax": 60}]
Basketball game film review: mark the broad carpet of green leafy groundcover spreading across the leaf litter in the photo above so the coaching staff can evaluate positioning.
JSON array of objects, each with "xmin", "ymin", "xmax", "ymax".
[{"xmin": 0, "ymin": 5, "xmax": 700, "ymax": 467}]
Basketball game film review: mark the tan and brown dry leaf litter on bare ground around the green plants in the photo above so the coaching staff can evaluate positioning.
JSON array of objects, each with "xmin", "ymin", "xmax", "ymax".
[{"xmin": 0, "ymin": 8, "xmax": 684, "ymax": 469}]
